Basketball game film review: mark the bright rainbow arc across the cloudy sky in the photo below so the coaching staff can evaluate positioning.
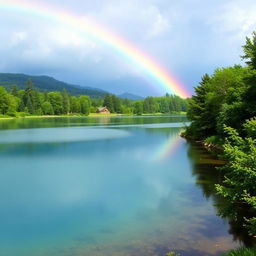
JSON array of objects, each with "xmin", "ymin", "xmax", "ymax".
[{"xmin": 0, "ymin": 0, "xmax": 191, "ymax": 98}]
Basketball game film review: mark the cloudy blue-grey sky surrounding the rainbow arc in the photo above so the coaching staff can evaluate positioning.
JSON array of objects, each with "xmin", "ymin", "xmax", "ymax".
[{"xmin": 0, "ymin": 0, "xmax": 256, "ymax": 96}]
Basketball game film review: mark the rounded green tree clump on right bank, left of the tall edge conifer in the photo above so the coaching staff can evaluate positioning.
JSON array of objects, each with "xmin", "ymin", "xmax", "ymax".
[{"xmin": 188, "ymin": 65, "xmax": 251, "ymax": 139}]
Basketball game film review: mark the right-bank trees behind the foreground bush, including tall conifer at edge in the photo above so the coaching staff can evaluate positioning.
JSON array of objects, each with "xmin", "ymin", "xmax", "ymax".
[{"xmin": 187, "ymin": 32, "xmax": 256, "ymax": 140}]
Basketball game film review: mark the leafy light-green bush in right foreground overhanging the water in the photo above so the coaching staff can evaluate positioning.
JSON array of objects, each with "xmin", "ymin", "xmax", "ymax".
[{"xmin": 216, "ymin": 119, "xmax": 256, "ymax": 235}]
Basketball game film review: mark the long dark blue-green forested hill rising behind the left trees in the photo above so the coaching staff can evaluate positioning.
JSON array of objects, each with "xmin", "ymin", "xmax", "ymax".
[{"xmin": 0, "ymin": 73, "xmax": 108, "ymax": 98}]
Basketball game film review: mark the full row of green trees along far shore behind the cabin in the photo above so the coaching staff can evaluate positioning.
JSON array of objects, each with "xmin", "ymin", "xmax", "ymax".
[{"xmin": 0, "ymin": 80, "xmax": 187, "ymax": 116}]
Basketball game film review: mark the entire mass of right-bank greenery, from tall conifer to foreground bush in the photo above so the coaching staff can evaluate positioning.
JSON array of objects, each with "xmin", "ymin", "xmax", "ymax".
[{"xmin": 185, "ymin": 32, "xmax": 256, "ymax": 236}]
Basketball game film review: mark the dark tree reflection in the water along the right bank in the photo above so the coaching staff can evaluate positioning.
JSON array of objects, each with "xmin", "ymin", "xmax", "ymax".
[{"xmin": 188, "ymin": 143, "xmax": 255, "ymax": 246}]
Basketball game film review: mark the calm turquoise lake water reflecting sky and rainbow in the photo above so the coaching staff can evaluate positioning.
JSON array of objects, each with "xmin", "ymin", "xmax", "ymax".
[{"xmin": 0, "ymin": 116, "xmax": 248, "ymax": 256}]
